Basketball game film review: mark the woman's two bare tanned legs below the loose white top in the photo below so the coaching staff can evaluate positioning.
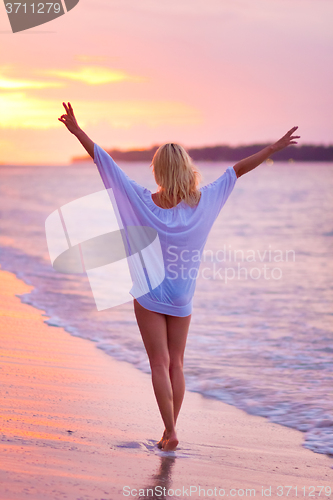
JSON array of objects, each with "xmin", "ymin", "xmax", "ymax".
[{"xmin": 134, "ymin": 300, "xmax": 191, "ymax": 451}]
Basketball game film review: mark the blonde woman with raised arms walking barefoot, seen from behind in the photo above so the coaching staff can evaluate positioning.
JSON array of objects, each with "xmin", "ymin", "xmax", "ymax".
[{"xmin": 59, "ymin": 103, "xmax": 299, "ymax": 451}]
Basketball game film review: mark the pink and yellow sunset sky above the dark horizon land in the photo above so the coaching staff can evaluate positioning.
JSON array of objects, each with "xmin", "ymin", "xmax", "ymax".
[{"xmin": 0, "ymin": 0, "xmax": 333, "ymax": 164}]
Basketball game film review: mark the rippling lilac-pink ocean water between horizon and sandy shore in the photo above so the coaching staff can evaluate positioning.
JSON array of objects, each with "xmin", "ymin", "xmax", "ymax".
[{"xmin": 0, "ymin": 159, "xmax": 333, "ymax": 456}]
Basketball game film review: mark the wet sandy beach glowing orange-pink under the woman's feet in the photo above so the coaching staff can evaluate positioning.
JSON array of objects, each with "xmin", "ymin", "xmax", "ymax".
[{"xmin": 0, "ymin": 271, "xmax": 333, "ymax": 500}]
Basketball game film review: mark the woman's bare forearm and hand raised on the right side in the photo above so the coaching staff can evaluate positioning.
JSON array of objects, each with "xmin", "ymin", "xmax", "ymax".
[{"xmin": 234, "ymin": 127, "xmax": 300, "ymax": 177}]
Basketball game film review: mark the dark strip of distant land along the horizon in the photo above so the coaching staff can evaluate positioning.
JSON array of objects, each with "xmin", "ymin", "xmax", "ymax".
[{"xmin": 72, "ymin": 144, "xmax": 333, "ymax": 163}]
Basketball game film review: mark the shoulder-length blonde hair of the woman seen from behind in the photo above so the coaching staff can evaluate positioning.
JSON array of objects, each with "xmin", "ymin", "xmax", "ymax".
[{"xmin": 151, "ymin": 143, "xmax": 201, "ymax": 208}]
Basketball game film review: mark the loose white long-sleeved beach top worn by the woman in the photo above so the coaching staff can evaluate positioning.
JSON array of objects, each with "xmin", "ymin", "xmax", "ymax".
[{"xmin": 94, "ymin": 144, "xmax": 237, "ymax": 317}]
